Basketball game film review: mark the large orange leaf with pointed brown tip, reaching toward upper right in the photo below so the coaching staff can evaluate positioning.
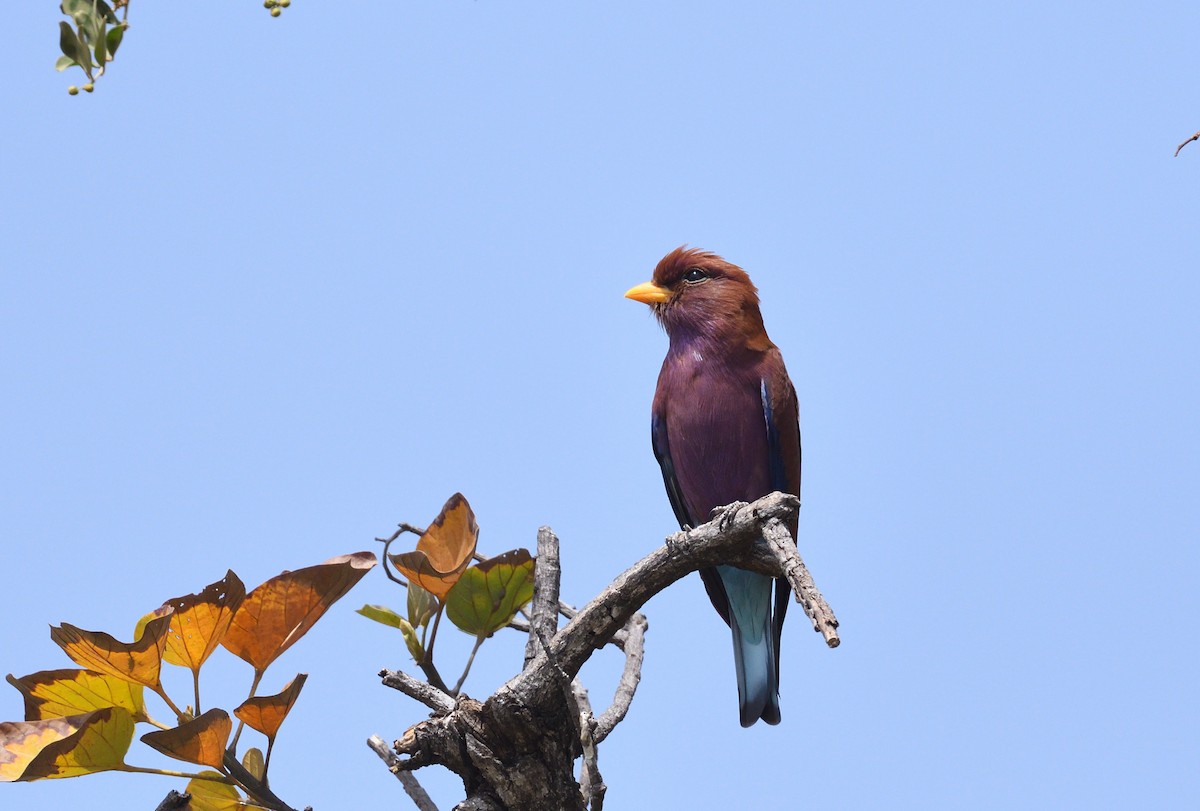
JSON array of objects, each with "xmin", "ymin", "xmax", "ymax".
[{"xmin": 221, "ymin": 552, "xmax": 377, "ymax": 672}]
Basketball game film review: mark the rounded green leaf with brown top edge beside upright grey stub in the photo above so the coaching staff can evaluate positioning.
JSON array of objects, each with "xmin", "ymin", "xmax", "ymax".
[{"xmin": 446, "ymin": 549, "xmax": 534, "ymax": 637}]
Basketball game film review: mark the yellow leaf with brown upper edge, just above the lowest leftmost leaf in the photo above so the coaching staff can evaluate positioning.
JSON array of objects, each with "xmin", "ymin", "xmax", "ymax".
[{"xmin": 7, "ymin": 668, "xmax": 146, "ymax": 721}]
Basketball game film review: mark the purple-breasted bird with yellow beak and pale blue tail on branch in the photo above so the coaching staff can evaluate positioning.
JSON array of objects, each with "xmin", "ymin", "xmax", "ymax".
[{"xmin": 625, "ymin": 246, "xmax": 800, "ymax": 727}]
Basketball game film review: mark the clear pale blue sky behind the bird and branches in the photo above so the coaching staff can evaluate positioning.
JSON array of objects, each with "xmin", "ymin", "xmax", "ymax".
[{"xmin": 0, "ymin": 0, "xmax": 1200, "ymax": 811}]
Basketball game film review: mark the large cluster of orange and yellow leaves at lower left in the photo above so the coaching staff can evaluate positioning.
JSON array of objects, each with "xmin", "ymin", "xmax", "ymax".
[{"xmin": 0, "ymin": 552, "xmax": 377, "ymax": 811}]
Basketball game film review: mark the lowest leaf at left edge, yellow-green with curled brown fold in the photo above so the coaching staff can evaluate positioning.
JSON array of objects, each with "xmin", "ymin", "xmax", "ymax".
[{"xmin": 0, "ymin": 707, "xmax": 133, "ymax": 782}]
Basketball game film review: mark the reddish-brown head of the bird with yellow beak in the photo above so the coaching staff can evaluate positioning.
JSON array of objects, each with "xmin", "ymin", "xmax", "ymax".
[{"xmin": 625, "ymin": 246, "xmax": 770, "ymax": 349}]
